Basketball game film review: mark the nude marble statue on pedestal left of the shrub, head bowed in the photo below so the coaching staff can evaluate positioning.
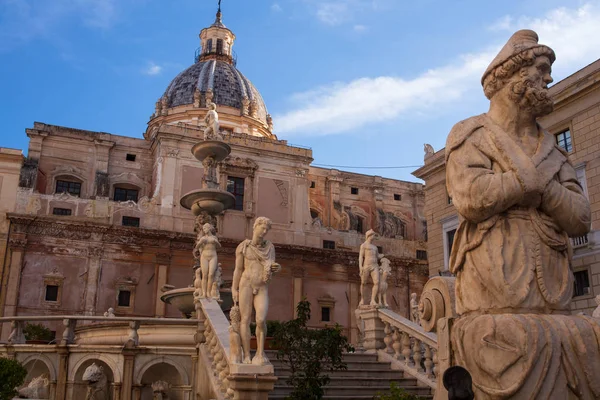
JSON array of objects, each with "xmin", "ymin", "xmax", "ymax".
[{"xmin": 231, "ymin": 217, "xmax": 281, "ymax": 365}]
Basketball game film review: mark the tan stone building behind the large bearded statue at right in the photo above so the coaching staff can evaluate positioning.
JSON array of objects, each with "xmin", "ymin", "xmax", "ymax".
[{"xmin": 413, "ymin": 60, "xmax": 600, "ymax": 315}]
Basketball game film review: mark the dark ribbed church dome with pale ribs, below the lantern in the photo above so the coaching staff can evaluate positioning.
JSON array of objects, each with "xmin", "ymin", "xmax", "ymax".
[{"xmin": 163, "ymin": 59, "xmax": 267, "ymax": 124}]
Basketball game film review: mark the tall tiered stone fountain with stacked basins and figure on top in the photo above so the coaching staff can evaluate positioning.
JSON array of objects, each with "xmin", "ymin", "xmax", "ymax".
[{"xmin": 160, "ymin": 103, "xmax": 235, "ymax": 317}]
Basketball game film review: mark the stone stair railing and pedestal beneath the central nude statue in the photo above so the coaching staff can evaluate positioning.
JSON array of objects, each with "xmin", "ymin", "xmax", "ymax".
[{"xmin": 196, "ymin": 299, "xmax": 277, "ymax": 400}]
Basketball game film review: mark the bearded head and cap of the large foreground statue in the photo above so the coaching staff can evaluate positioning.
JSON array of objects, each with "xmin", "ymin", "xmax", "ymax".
[{"xmin": 481, "ymin": 29, "xmax": 556, "ymax": 117}]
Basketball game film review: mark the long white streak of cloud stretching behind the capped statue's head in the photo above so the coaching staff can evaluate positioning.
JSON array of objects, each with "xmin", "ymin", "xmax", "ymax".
[{"xmin": 274, "ymin": 1, "xmax": 600, "ymax": 135}]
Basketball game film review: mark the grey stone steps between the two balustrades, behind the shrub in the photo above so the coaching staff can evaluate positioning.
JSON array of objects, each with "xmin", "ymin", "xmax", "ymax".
[{"xmin": 267, "ymin": 351, "xmax": 433, "ymax": 400}]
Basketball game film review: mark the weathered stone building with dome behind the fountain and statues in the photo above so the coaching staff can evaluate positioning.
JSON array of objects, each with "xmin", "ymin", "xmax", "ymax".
[{"xmin": 0, "ymin": 15, "xmax": 427, "ymax": 340}]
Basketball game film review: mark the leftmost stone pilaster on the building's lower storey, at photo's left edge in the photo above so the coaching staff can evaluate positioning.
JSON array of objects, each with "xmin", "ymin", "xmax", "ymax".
[{"xmin": 0, "ymin": 234, "xmax": 27, "ymax": 340}]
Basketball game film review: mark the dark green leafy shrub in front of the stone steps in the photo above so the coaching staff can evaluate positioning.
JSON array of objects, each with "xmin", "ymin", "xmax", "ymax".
[{"xmin": 273, "ymin": 299, "xmax": 354, "ymax": 400}]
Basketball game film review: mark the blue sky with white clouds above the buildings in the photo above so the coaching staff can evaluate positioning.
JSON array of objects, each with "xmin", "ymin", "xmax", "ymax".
[{"xmin": 0, "ymin": 0, "xmax": 600, "ymax": 181}]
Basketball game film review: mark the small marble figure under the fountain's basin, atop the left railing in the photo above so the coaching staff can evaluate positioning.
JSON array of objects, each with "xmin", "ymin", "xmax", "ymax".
[{"xmin": 194, "ymin": 223, "xmax": 221, "ymax": 298}]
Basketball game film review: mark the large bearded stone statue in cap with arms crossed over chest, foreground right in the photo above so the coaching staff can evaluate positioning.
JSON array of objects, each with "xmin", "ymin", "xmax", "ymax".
[{"xmin": 446, "ymin": 30, "xmax": 600, "ymax": 399}]
